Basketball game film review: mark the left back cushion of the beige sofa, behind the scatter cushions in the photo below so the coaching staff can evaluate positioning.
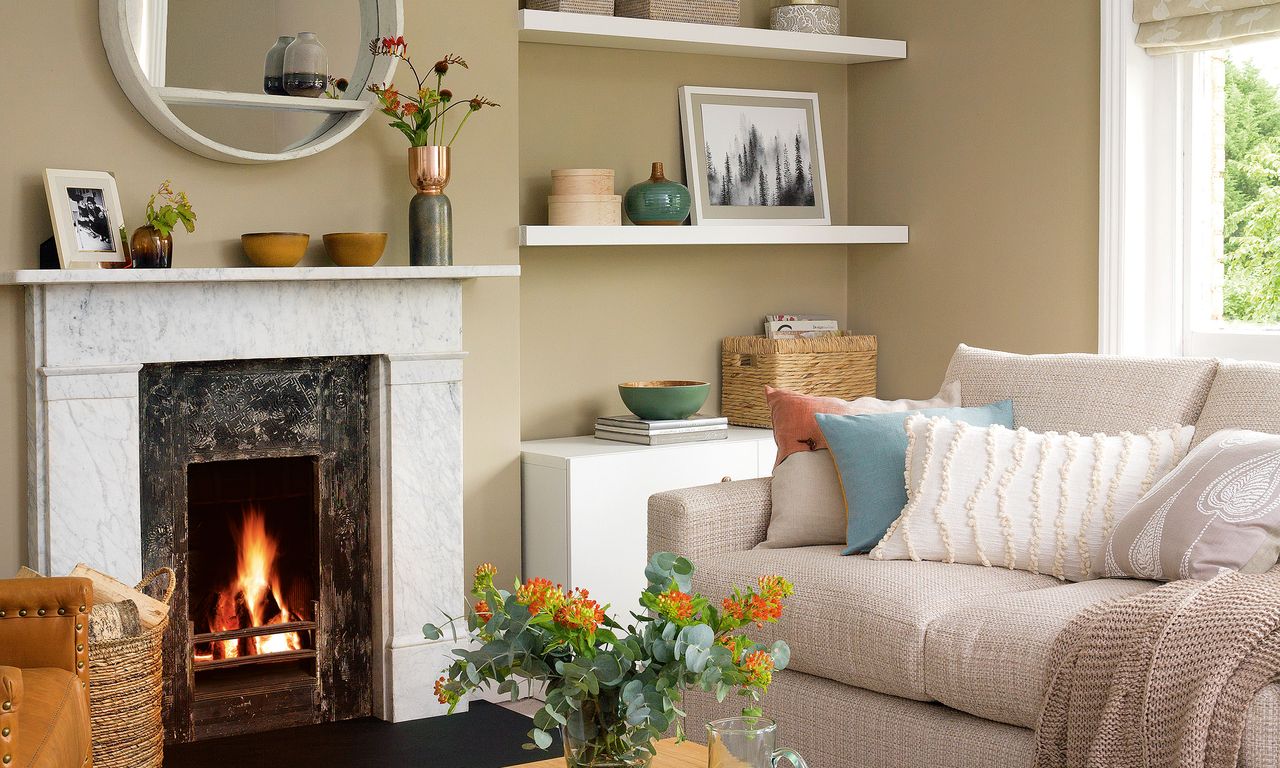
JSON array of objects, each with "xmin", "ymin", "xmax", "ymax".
[{"xmin": 946, "ymin": 344, "xmax": 1213, "ymax": 434}]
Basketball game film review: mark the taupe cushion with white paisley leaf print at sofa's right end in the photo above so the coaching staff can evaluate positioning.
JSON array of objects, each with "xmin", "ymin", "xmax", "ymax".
[{"xmin": 1106, "ymin": 430, "xmax": 1280, "ymax": 581}]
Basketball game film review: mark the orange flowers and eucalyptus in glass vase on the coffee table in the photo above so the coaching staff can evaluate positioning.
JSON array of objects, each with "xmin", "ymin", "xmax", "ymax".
[{"xmin": 422, "ymin": 552, "xmax": 792, "ymax": 768}]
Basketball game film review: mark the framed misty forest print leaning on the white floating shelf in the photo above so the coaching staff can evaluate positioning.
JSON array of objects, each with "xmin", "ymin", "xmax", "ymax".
[{"xmin": 680, "ymin": 86, "xmax": 831, "ymax": 224}]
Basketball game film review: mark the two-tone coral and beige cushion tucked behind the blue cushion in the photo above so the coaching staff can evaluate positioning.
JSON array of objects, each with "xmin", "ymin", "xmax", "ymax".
[{"xmin": 759, "ymin": 383, "xmax": 960, "ymax": 549}]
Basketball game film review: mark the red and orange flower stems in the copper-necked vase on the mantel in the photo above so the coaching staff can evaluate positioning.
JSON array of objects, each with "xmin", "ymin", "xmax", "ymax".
[{"xmin": 369, "ymin": 36, "xmax": 499, "ymax": 147}]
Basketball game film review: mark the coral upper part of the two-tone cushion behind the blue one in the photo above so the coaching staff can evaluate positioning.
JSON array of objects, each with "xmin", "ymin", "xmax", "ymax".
[{"xmin": 764, "ymin": 381, "xmax": 960, "ymax": 467}]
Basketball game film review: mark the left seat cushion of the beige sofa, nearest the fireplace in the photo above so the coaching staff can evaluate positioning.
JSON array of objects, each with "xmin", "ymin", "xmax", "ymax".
[{"xmin": 694, "ymin": 547, "xmax": 1061, "ymax": 701}]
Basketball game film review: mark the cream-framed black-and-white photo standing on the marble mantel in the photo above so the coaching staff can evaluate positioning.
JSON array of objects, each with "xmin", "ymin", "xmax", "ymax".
[{"xmin": 45, "ymin": 168, "xmax": 128, "ymax": 269}]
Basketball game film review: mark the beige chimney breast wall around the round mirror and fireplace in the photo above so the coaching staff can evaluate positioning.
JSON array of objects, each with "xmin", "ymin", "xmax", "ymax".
[{"xmin": 0, "ymin": 0, "xmax": 520, "ymax": 576}]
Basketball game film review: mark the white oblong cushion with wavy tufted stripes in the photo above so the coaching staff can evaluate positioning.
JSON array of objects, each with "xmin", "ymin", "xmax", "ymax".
[{"xmin": 872, "ymin": 416, "xmax": 1194, "ymax": 581}]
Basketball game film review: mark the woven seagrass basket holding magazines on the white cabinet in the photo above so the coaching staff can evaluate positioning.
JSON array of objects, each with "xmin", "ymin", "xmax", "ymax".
[{"xmin": 721, "ymin": 334, "xmax": 876, "ymax": 426}]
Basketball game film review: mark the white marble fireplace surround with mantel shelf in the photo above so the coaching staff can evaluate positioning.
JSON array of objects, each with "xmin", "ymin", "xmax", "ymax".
[{"xmin": 0, "ymin": 266, "xmax": 520, "ymax": 722}]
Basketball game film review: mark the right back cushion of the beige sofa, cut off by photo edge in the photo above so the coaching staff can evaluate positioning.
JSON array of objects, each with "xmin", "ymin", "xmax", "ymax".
[{"xmin": 1196, "ymin": 360, "xmax": 1280, "ymax": 444}]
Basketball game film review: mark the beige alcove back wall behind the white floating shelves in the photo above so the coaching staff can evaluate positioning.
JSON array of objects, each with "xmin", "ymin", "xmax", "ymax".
[{"xmin": 520, "ymin": 0, "xmax": 847, "ymax": 439}]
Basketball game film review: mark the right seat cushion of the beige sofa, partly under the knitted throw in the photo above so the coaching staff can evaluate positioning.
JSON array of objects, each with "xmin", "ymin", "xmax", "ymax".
[{"xmin": 924, "ymin": 579, "xmax": 1158, "ymax": 728}]
